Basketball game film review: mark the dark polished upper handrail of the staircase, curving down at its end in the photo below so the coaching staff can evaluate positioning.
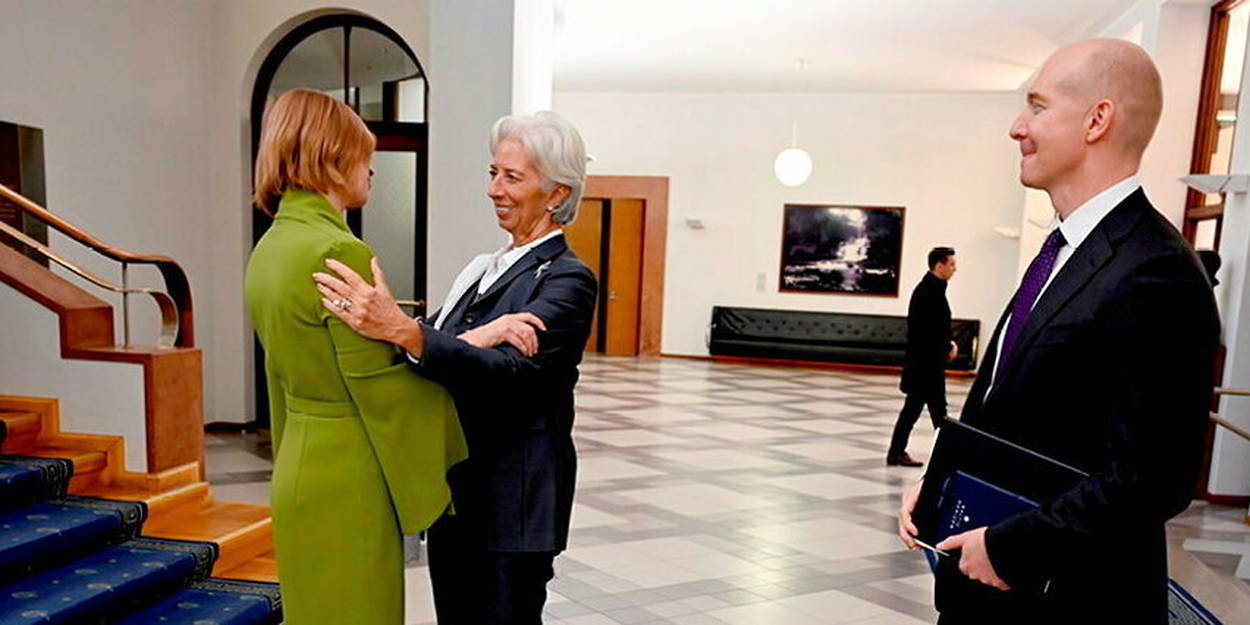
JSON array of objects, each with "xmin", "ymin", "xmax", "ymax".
[{"xmin": 0, "ymin": 185, "xmax": 195, "ymax": 348}]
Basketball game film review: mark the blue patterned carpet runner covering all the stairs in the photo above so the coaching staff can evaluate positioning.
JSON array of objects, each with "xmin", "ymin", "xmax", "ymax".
[{"xmin": 0, "ymin": 455, "xmax": 281, "ymax": 625}]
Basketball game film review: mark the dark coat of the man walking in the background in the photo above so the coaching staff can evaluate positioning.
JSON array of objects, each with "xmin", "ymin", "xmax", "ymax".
[{"xmin": 899, "ymin": 271, "xmax": 950, "ymax": 396}]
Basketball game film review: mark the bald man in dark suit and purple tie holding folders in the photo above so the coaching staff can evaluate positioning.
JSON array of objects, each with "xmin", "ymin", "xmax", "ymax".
[{"xmin": 900, "ymin": 40, "xmax": 1219, "ymax": 624}]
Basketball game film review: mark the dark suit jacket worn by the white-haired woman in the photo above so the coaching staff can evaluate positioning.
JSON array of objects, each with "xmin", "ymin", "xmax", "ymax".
[{"xmin": 416, "ymin": 236, "xmax": 598, "ymax": 551}]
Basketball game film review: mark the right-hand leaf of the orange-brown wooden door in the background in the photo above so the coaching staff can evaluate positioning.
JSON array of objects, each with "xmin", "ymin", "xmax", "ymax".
[{"xmin": 600, "ymin": 199, "xmax": 644, "ymax": 356}]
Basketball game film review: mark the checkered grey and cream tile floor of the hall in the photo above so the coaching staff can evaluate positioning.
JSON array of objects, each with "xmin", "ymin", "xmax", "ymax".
[{"xmin": 208, "ymin": 355, "xmax": 1250, "ymax": 625}]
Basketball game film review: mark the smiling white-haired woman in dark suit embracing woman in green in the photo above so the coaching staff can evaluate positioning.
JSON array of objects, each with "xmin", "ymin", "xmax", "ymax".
[{"xmin": 314, "ymin": 113, "xmax": 598, "ymax": 624}]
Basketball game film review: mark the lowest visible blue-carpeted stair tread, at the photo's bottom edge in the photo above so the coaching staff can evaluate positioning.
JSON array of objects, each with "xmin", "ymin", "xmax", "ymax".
[{"xmin": 116, "ymin": 579, "xmax": 283, "ymax": 625}]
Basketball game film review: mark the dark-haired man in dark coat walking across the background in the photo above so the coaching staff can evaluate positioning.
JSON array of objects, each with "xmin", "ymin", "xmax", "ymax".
[{"xmin": 885, "ymin": 248, "xmax": 956, "ymax": 466}]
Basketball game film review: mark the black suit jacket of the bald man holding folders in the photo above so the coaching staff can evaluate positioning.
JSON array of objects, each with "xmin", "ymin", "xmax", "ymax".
[{"xmin": 936, "ymin": 189, "xmax": 1219, "ymax": 624}]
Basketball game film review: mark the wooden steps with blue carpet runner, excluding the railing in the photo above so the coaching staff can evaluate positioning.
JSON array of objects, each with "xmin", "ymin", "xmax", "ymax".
[{"xmin": 0, "ymin": 396, "xmax": 281, "ymax": 625}]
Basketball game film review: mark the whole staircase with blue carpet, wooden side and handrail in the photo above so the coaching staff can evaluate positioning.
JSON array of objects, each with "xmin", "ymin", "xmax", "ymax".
[{"xmin": 0, "ymin": 185, "xmax": 281, "ymax": 625}]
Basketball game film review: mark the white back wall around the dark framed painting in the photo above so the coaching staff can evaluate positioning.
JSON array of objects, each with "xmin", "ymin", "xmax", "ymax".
[{"xmin": 555, "ymin": 93, "xmax": 1023, "ymax": 355}]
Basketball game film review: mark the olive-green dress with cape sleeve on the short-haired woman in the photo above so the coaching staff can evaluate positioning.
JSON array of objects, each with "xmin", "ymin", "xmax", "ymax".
[{"xmin": 244, "ymin": 190, "xmax": 468, "ymax": 625}]
